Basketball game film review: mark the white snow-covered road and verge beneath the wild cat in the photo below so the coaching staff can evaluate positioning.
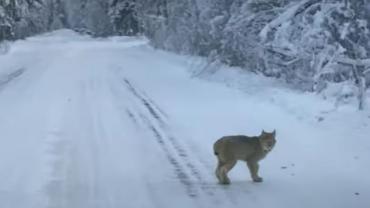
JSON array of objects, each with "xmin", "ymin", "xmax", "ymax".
[{"xmin": 0, "ymin": 30, "xmax": 370, "ymax": 208}]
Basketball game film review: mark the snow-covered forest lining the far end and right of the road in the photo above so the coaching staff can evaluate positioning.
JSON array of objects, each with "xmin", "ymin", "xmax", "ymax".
[{"xmin": 0, "ymin": 0, "xmax": 370, "ymax": 110}]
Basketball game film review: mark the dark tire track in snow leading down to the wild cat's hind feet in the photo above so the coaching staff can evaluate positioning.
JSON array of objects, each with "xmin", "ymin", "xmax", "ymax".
[{"xmin": 124, "ymin": 79, "xmax": 215, "ymax": 197}]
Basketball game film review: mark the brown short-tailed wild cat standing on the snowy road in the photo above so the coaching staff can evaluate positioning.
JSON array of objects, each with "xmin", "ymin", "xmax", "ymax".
[{"xmin": 213, "ymin": 130, "xmax": 276, "ymax": 184}]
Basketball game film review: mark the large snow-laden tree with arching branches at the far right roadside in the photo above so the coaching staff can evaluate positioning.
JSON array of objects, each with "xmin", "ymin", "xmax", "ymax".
[{"xmin": 260, "ymin": 0, "xmax": 370, "ymax": 109}]
